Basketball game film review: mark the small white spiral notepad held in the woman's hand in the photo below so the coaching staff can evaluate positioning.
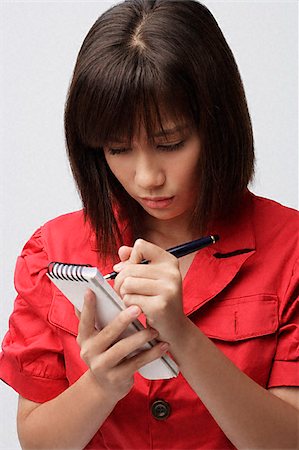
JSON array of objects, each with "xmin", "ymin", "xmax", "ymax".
[{"xmin": 47, "ymin": 262, "xmax": 179, "ymax": 380}]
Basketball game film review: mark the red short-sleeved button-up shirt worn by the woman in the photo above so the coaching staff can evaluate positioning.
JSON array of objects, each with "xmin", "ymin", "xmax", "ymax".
[{"xmin": 0, "ymin": 193, "xmax": 299, "ymax": 450}]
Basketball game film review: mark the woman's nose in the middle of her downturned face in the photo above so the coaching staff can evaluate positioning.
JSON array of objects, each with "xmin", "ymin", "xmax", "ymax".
[{"xmin": 135, "ymin": 153, "xmax": 166, "ymax": 190}]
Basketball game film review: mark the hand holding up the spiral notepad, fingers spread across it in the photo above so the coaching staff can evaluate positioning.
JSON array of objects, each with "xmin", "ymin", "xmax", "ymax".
[{"xmin": 77, "ymin": 290, "xmax": 168, "ymax": 401}]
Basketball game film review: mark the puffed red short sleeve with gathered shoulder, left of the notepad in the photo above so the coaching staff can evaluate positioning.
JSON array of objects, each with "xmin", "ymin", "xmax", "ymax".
[{"xmin": 0, "ymin": 229, "xmax": 68, "ymax": 402}]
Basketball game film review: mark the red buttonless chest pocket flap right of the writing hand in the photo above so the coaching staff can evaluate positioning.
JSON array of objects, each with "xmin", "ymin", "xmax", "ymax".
[{"xmin": 190, "ymin": 294, "xmax": 278, "ymax": 342}]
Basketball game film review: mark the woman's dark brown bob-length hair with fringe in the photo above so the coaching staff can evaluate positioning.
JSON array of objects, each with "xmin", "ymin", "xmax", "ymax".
[{"xmin": 65, "ymin": 0, "xmax": 254, "ymax": 255}]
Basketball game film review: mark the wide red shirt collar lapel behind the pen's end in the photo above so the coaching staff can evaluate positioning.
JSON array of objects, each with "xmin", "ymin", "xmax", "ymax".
[{"xmin": 183, "ymin": 192, "xmax": 255, "ymax": 314}]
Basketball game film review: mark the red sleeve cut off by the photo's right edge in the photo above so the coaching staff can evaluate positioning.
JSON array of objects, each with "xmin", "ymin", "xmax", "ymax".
[{"xmin": 268, "ymin": 260, "xmax": 299, "ymax": 388}]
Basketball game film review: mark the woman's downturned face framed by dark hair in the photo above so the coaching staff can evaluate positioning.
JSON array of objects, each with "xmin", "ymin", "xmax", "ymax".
[{"xmin": 104, "ymin": 122, "xmax": 200, "ymax": 227}]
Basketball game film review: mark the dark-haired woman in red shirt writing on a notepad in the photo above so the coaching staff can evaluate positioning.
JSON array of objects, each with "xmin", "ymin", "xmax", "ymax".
[{"xmin": 0, "ymin": 0, "xmax": 298, "ymax": 450}]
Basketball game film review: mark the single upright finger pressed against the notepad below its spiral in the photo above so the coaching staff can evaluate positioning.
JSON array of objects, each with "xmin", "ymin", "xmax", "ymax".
[{"xmin": 78, "ymin": 289, "xmax": 96, "ymax": 342}]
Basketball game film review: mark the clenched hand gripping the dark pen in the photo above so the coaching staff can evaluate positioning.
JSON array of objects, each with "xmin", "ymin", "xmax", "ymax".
[{"xmin": 114, "ymin": 239, "xmax": 186, "ymax": 343}]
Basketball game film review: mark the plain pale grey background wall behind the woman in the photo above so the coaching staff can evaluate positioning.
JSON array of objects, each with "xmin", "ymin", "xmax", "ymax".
[{"xmin": 0, "ymin": 0, "xmax": 298, "ymax": 450}]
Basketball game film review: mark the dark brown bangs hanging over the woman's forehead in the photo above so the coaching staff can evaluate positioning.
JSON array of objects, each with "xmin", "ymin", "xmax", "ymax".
[{"xmin": 70, "ymin": 52, "xmax": 198, "ymax": 149}]
